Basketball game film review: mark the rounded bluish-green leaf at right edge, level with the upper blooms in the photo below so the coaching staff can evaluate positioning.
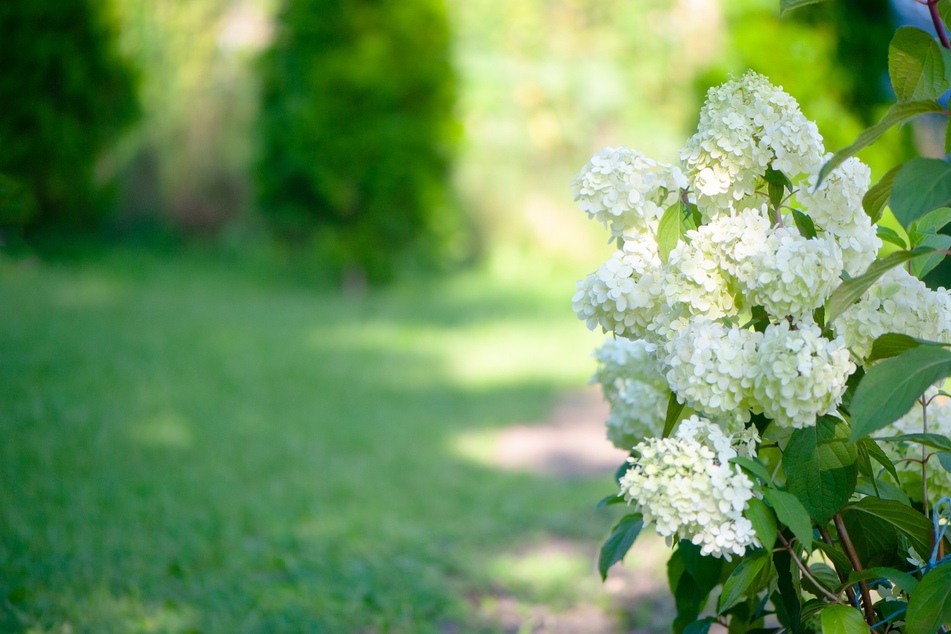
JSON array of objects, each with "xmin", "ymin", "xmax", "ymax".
[{"xmin": 890, "ymin": 158, "xmax": 951, "ymax": 228}]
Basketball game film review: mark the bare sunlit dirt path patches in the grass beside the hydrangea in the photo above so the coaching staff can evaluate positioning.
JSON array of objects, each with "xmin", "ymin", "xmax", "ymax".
[{"xmin": 470, "ymin": 389, "xmax": 673, "ymax": 634}]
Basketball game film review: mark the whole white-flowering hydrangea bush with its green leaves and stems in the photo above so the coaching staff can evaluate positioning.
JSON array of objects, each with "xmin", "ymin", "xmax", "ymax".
[{"xmin": 572, "ymin": 0, "xmax": 951, "ymax": 634}]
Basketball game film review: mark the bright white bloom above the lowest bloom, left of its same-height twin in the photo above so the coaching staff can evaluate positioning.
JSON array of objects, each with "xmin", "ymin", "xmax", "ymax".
[{"xmin": 662, "ymin": 318, "xmax": 763, "ymax": 421}]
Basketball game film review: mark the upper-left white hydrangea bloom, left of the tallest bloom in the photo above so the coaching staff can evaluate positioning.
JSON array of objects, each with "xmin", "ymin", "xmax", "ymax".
[{"xmin": 571, "ymin": 147, "xmax": 687, "ymax": 238}]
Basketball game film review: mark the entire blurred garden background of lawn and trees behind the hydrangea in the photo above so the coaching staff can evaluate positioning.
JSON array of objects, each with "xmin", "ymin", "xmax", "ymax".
[{"xmin": 0, "ymin": 0, "xmax": 943, "ymax": 634}]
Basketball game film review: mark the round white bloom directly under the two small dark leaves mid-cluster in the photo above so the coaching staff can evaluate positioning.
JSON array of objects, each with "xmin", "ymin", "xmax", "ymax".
[{"xmin": 737, "ymin": 227, "xmax": 842, "ymax": 318}]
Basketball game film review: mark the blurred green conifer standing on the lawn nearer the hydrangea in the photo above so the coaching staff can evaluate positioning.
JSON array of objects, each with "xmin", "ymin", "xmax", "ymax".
[{"xmin": 256, "ymin": 0, "xmax": 464, "ymax": 281}]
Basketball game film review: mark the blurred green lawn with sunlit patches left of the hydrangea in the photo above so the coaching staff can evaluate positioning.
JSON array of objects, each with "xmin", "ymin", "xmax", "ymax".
[{"xmin": 0, "ymin": 247, "xmax": 640, "ymax": 634}]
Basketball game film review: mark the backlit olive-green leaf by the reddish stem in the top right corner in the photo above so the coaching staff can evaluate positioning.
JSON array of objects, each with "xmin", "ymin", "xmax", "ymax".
[{"xmin": 888, "ymin": 26, "xmax": 948, "ymax": 103}]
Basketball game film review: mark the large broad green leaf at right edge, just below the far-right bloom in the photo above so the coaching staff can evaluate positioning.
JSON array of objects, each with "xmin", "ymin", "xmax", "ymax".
[{"xmin": 850, "ymin": 346, "xmax": 951, "ymax": 440}]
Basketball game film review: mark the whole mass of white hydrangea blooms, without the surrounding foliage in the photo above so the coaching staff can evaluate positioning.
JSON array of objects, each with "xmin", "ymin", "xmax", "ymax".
[{"xmin": 572, "ymin": 72, "xmax": 951, "ymax": 556}]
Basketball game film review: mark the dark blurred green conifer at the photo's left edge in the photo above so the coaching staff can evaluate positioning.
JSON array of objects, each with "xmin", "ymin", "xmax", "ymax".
[{"xmin": 0, "ymin": 0, "xmax": 138, "ymax": 232}]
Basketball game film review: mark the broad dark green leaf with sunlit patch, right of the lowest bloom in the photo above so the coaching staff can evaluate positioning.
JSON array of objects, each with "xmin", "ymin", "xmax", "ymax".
[{"xmin": 783, "ymin": 417, "xmax": 858, "ymax": 526}]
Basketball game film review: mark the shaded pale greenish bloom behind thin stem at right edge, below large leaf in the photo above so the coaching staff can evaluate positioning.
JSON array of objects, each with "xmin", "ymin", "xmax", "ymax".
[{"xmin": 876, "ymin": 387, "xmax": 951, "ymax": 506}]
